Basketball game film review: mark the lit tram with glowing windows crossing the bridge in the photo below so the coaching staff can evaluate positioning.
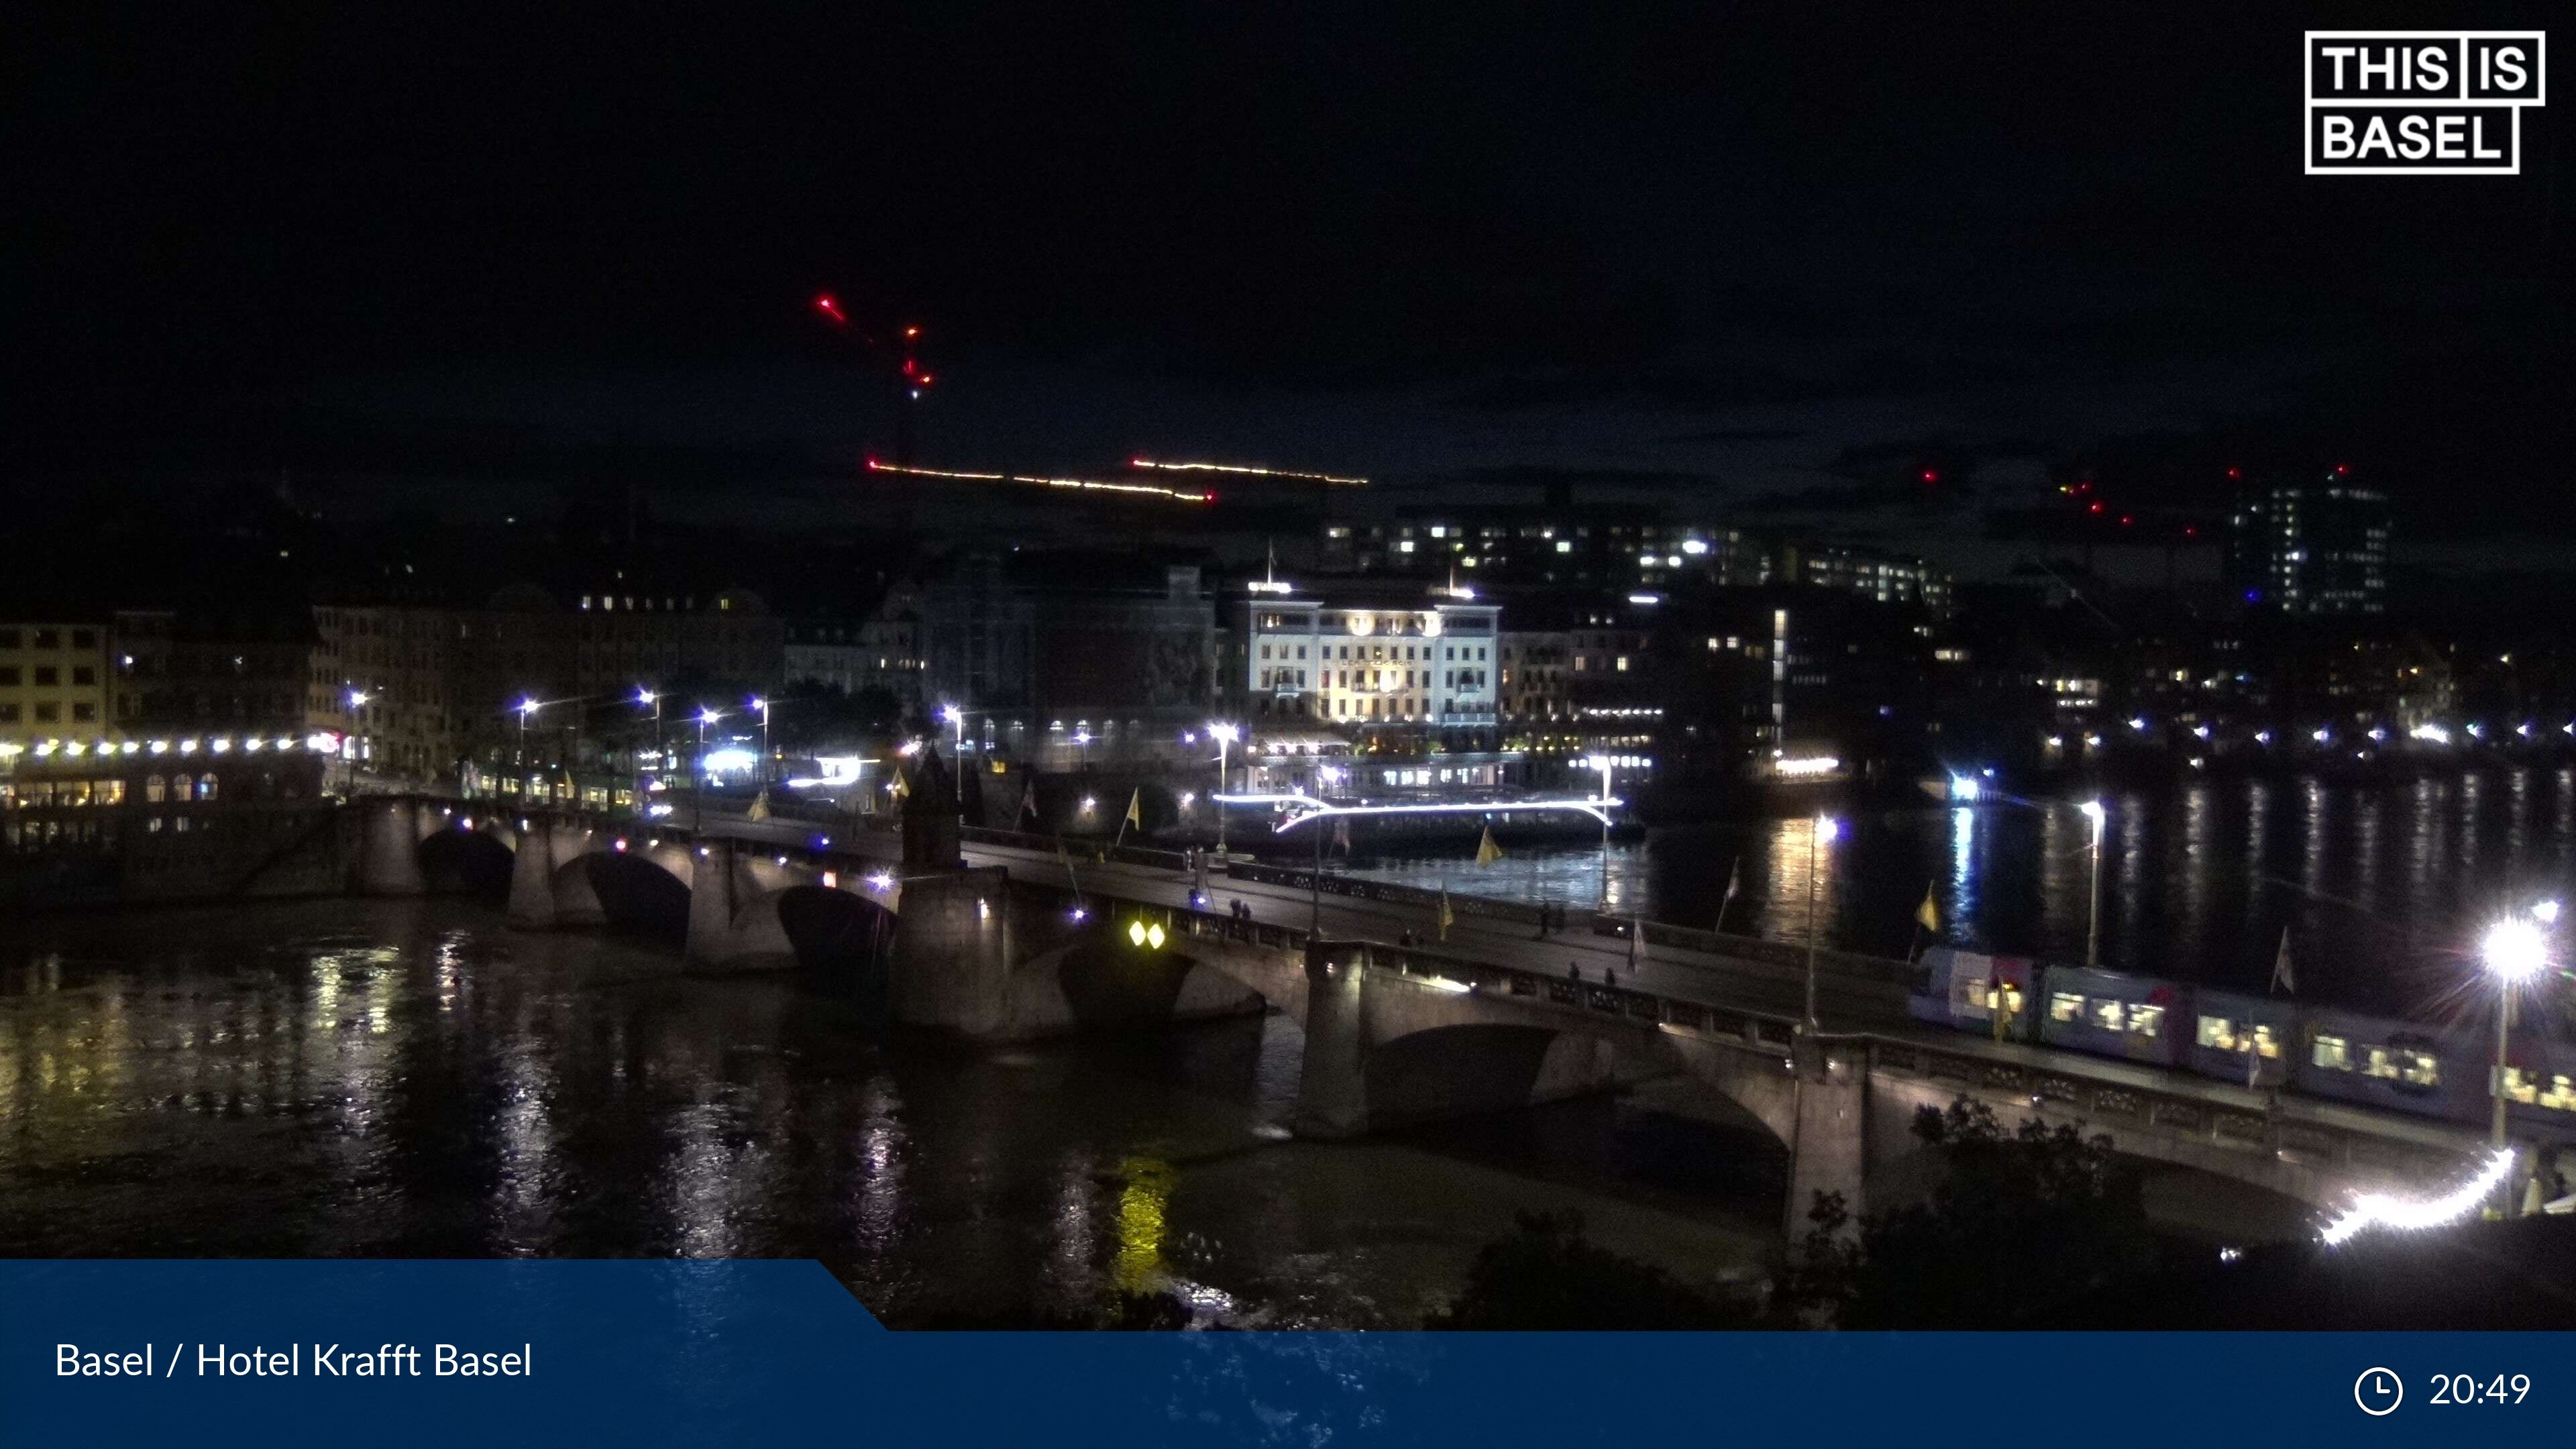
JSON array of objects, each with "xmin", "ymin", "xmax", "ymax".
[{"xmin": 1909, "ymin": 947, "xmax": 2576, "ymax": 1147}]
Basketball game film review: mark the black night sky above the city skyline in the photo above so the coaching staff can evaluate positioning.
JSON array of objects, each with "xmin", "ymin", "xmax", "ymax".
[{"xmin": 0, "ymin": 3, "xmax": 2576, "ymax": 575}]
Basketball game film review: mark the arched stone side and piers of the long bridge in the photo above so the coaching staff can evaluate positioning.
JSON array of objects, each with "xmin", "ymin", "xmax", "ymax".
[{"xmin": 342, "ymin": 784, "xmax": 2475, "ymax": 1238}]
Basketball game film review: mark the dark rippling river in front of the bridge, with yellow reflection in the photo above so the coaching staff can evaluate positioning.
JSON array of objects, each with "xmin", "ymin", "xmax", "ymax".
[{"xmin": 0, "ymin": 900, "xmax": 1785, "ymax": 1328}]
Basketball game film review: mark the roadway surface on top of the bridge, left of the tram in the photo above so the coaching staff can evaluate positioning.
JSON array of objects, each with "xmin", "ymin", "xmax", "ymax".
[{"xmin": 703, "ymin": 815, "xmax": 2483, "ymax": 1161}]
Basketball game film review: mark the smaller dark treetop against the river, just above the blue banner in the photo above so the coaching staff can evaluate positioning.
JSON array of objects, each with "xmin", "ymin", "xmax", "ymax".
[{"xmin": 1425, "ymin": 1212, "xmax": 1757, "ymax": 1328}]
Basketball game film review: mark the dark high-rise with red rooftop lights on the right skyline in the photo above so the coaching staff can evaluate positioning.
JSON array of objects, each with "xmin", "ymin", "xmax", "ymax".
[{"xmin": 2229, "ymin": 467, "xmax": 2391, "ymax": 614}]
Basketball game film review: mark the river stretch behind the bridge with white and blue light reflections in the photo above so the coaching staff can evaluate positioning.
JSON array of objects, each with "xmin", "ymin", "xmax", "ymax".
[{"xmin": 1350, "ymin": 768, "xmax": 2576, "ymax": 1016}]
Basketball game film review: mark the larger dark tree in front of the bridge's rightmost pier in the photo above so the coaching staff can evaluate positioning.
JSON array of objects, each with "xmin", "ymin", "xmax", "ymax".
[{"xmin": 1782, "ymin": 1098, "xmax": 2156, "ymax": 1328}]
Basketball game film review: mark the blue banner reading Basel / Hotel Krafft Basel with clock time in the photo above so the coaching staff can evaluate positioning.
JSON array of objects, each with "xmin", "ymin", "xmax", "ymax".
[{"xmin": 0, "ymin": 1260, "xmax": 2544, "ymax": 1449}]
